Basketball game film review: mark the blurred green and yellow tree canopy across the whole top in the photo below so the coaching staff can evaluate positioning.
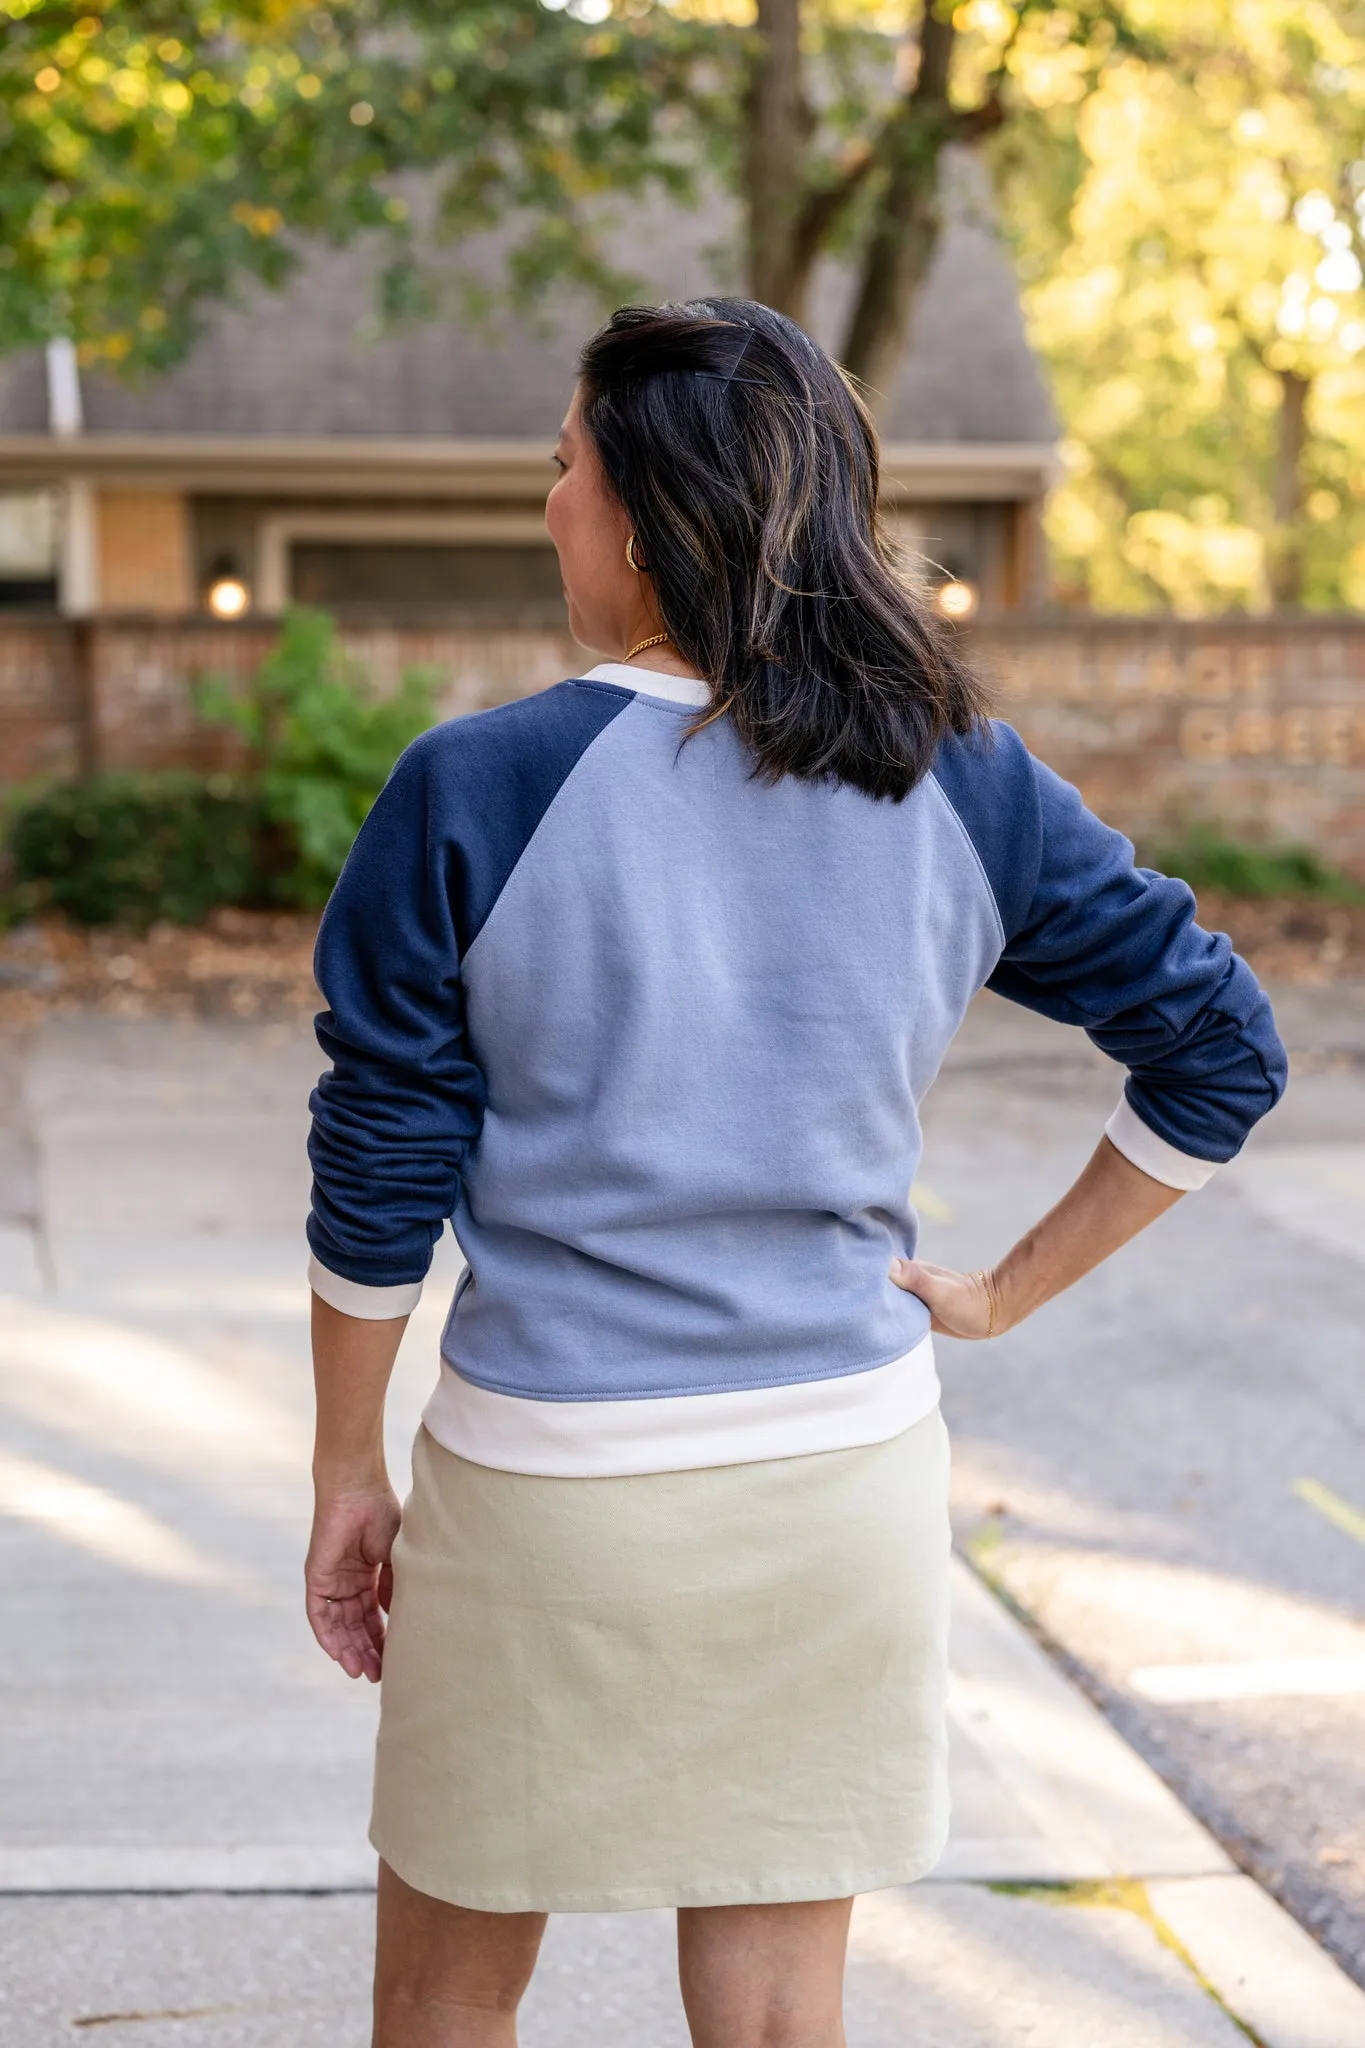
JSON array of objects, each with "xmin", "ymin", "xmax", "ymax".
[{"xmin": 10, "ymin": 0, "xmax": 1365, "ymax": 612}]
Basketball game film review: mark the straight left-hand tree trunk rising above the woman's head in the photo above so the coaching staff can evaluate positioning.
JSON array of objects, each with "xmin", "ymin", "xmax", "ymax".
[{"xmin": 745, "ymin": 0, "xmax": 810, "ymax": 319}]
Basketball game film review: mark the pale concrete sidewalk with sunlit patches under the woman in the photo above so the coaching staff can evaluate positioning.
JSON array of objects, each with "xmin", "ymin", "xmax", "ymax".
[{"xmin": 0, "ymin": 1022, "xmax": 1365, "ymax": 2048}]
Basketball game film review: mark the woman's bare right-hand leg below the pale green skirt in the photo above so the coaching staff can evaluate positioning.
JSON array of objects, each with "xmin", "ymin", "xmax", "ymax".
[{"xmin": 677, "ymin": 1898, "xmax": 853, "ymax": 2048}]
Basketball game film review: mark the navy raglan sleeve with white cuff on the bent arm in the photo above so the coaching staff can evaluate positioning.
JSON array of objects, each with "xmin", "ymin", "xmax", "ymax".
[{"xmin": 933, "ymin": 723, "xmax": 1287, "ymax": 1188}]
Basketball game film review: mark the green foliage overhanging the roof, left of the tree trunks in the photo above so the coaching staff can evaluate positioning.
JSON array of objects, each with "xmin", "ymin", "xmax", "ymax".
[{"xmin": 0, "ymin": 0, "xmax": 733, "ymax": 369}]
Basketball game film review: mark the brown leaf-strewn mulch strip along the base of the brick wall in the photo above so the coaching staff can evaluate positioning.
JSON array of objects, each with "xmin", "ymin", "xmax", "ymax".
[{"xmin": 0, "ymin": 893, "xmax": 1365, "ymax": 1024}]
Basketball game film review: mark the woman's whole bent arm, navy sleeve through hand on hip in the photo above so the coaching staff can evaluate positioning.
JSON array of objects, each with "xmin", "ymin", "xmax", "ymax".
[{"xmin": 916, "ymin": 725, "xmax": 1287, "ymax": 1337}]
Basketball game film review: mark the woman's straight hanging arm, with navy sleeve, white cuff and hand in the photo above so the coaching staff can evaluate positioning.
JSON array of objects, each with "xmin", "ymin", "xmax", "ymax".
[{"xmin": 307, "ymin": 686, "xmax": 630, "ymax": 1677}]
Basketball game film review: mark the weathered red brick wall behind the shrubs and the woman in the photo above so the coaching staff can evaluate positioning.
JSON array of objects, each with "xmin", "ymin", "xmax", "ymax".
[{"xmin": 0, "ymin": 618, "xmax": 1365, "ymax": 879}]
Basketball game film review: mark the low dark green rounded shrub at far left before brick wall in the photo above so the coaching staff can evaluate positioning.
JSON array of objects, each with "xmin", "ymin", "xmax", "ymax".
[{"xmin": 8, "ymin": 772, "xmax": 268, "ymax": 928}]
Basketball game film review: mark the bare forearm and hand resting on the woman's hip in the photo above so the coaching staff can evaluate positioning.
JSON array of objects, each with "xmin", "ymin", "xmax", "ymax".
[{"xmin": 890, "ymin": 1139, "xmax": 1185, "ymax": 1337}]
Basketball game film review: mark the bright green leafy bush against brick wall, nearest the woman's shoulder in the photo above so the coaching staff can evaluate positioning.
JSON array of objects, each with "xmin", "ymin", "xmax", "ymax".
[{"xmin": 199, "ymin": 608, "xmax": 434, "ymax": 909}]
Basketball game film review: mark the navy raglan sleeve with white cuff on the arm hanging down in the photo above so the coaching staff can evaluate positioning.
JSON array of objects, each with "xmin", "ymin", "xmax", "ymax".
[{"xmin": 307, "ymin": 684, "xmax": 630, "ymax": 1319}]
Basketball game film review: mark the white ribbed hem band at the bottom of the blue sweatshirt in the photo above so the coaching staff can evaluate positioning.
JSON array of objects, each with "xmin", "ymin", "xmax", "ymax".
[{"xmin": 422, "ymin": 1337, "xmax": 939, "ymax": 1479}]
